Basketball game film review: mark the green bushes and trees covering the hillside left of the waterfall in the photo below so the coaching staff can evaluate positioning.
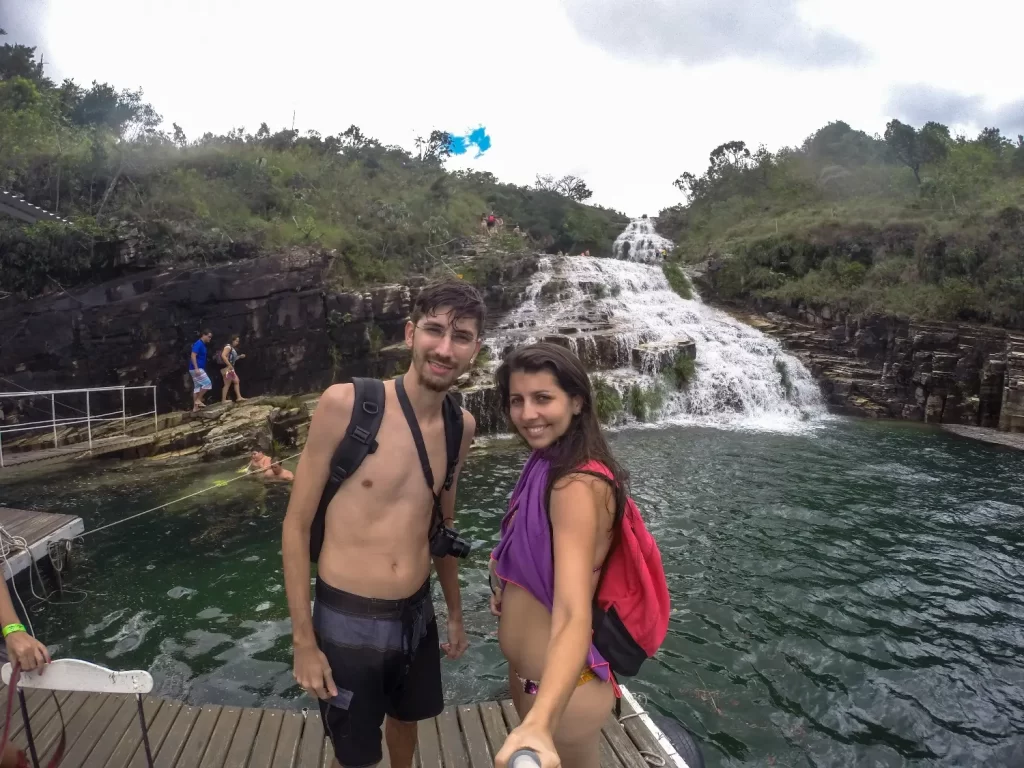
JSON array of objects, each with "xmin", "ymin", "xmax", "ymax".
[{"xmin": 0, "ymin": 38, "xmax": 627, "ymax": 295}]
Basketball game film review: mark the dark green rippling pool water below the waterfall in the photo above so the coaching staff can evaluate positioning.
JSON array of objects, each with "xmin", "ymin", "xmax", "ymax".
[{"xmin": 0, "ymin": 420, "xmax": 1024, "ymax": 766}]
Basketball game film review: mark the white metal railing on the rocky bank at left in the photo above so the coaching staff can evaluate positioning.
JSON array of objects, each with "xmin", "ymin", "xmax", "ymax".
[{"xmin": 0, "ymin": 385, "xmax": 160, "ymax": 467}]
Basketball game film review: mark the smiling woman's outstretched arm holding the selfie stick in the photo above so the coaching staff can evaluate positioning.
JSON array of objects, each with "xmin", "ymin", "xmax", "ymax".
[{"xmin": 495, "ymin": 474, "xmax": 610, "ymax": 768}]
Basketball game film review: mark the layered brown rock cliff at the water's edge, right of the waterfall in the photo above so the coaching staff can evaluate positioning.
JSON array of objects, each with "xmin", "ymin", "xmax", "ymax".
[{"xmin": 737, "ymin": 300, "xmax": 1024, "ymax": 431}]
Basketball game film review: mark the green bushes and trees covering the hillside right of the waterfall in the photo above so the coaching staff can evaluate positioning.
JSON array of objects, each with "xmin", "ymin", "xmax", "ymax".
[{"xmin": 658, "ymin": 120, "xmax": 1024, "ymax": 328}]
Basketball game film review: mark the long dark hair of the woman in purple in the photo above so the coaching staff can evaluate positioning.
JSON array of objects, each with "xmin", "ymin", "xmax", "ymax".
[{"xmin": 495, "ymin": 342, "xmax": 630, "ymax": 530}]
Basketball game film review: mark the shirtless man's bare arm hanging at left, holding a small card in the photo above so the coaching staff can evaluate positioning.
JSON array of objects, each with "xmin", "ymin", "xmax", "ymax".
[{"xmin": 281, "ymin": 384, "xmax": 354, "ymax": 698}]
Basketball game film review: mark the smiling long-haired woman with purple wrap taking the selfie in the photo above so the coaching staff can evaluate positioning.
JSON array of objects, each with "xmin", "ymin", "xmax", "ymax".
[{"xmin": 490, "ymin": 343, "xmax": 629, "ymax": 768}]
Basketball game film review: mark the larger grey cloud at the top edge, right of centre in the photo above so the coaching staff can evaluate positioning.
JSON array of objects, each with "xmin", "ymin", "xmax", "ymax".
[{"xmin": 563, "ymin": 0, "xmax": 866, "ymax": 69}]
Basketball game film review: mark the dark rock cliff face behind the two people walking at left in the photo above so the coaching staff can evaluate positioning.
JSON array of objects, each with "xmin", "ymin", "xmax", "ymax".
[{"xmin": 0, "ymin": 244, "xmax": 536, "ymax": 418}]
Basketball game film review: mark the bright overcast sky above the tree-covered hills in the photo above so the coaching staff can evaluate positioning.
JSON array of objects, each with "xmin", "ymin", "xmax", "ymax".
[{"xmin": 0, "ymin": 0, "xmax": 1024, "ymax": 216}]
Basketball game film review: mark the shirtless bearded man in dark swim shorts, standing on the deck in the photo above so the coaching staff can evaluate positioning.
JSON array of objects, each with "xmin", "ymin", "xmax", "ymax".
[{"xmin": 282, "ymin": 282, "xmax": 485, "ymax": 768}]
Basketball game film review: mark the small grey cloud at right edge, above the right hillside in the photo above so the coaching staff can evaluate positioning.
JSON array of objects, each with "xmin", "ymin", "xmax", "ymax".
[{"xmin": 886, "ymin": 83, "xmax": 1024, "ymax": 135}]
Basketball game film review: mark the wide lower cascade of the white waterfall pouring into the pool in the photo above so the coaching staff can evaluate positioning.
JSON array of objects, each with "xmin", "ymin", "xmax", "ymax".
[{"xmin": 486, "ymin": 243, "xmax": 826, "ymax": 429}]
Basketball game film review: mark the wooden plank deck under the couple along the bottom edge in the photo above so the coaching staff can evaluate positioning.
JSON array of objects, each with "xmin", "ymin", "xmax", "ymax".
[{"xmin": 0, "ymin": 686, "xmax": 673, "ymax": 768}]
